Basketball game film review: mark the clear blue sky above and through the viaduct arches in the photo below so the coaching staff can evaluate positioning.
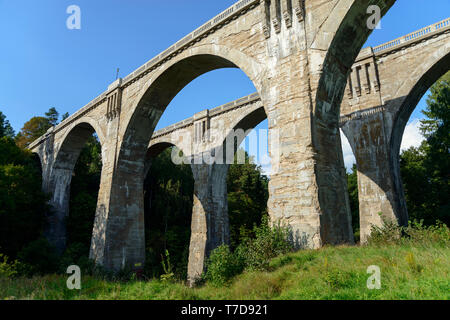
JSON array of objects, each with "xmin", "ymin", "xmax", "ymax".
[{"xmin": 0, "ymin": 0, "xmax": 450, "ymax": 172}]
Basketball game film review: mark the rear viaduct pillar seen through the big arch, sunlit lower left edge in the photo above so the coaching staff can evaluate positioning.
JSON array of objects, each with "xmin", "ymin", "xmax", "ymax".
[{"xmin": 188, "ymin": 164, "xmax": 230, "ymax": 285}]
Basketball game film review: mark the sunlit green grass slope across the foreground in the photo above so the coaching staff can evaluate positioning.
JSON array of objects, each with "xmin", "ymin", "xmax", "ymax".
[{"xmin": 0, "ymin": 243, "xmax": 450, "ymax": 300}]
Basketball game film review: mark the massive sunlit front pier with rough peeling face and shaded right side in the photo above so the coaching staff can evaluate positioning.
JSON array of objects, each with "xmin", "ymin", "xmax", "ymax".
[{"xmin": 262, "ymin": 56, "xmax": 353, "ymax": 248}]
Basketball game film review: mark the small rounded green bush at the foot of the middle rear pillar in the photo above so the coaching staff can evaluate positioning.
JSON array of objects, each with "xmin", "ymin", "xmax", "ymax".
[{"xmin": 205, "ymin": 245, "xmax": 244, "ymax": 286}]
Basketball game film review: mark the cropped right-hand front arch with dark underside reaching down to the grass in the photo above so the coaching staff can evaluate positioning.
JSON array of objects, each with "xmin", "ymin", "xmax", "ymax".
[{"xmin": 300, "ymin": 0, "xmax": 395, "ymax": 248}]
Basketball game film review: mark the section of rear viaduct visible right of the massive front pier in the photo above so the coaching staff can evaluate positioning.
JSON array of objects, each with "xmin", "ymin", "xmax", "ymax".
[{"xmin": 341, "ymin": 19, "xmax": 450, "ymax": 242}]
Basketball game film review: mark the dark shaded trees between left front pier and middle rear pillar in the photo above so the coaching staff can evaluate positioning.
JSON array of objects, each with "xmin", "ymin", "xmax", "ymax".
[{"xmin": 144, "ymin": 148, "xmax": 194, "ymax": 279}]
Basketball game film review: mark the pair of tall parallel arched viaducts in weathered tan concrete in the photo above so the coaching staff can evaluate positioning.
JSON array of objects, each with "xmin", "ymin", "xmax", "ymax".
[{"xmin": 29, "ymin": 0, "xmax": 450, "ymax": 282}]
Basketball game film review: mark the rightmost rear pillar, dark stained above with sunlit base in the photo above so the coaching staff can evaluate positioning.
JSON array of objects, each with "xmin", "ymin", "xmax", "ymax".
[{"xmin": 342, "ymin": 110, "xmax": 408, "ymax": 243}]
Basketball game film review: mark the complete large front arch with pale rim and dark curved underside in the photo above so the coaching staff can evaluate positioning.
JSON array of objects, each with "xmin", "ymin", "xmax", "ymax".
[{"xmin": 94, "ymin": 45, "xmax": 262, "ymax": 269}]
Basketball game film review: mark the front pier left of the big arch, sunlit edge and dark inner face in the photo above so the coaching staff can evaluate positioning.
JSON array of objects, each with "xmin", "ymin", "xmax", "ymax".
[{"xmin": 90, "ymin": 111, "xmax": 147, "ymax": 271}]
